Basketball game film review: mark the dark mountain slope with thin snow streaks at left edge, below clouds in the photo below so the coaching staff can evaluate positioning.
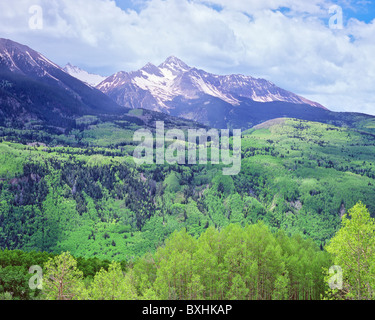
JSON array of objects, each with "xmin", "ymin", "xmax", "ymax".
[{"xmin": 0, "ymin": 39, "xmax": 124, "ymax": 131}]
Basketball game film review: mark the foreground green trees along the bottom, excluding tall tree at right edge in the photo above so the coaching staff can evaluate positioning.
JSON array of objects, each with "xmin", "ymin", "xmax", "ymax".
[{"xmin": 0, "ymin": 223, "xmax": 331, "ymax": 300}]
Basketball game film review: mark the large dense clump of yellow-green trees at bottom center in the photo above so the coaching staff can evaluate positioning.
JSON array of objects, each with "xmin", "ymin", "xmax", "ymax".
[{"xmin": 134, "ymin": 223, "xmax": 330, "ymax": 300}]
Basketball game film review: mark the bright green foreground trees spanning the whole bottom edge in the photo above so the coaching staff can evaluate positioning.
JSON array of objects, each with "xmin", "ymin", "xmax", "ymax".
[{"xmin": 0, "ymin": 202, "xmax": 375, "ymax": 301}]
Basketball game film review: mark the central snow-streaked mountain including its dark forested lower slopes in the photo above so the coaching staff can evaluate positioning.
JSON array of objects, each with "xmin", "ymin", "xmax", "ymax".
[{"xmin": 97, "ymin": 56, "xmax": 374, "ymax": 132}]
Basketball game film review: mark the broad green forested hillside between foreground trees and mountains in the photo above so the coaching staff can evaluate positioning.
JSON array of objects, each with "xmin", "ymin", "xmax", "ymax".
[{"xmin": 0, "ymin": 119, "xmax": 375, "ymax": 261}]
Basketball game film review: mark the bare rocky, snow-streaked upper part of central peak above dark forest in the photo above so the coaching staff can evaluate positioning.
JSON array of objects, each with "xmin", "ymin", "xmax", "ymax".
[{"xmin": 97, "ymin": 56, "xmax": 325, "ymax": 113}]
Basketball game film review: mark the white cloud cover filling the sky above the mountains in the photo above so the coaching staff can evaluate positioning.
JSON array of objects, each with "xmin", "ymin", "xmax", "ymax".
[{"xmin": 0, "ymin": 0, "xmax": 375, "ymax": 114}]
